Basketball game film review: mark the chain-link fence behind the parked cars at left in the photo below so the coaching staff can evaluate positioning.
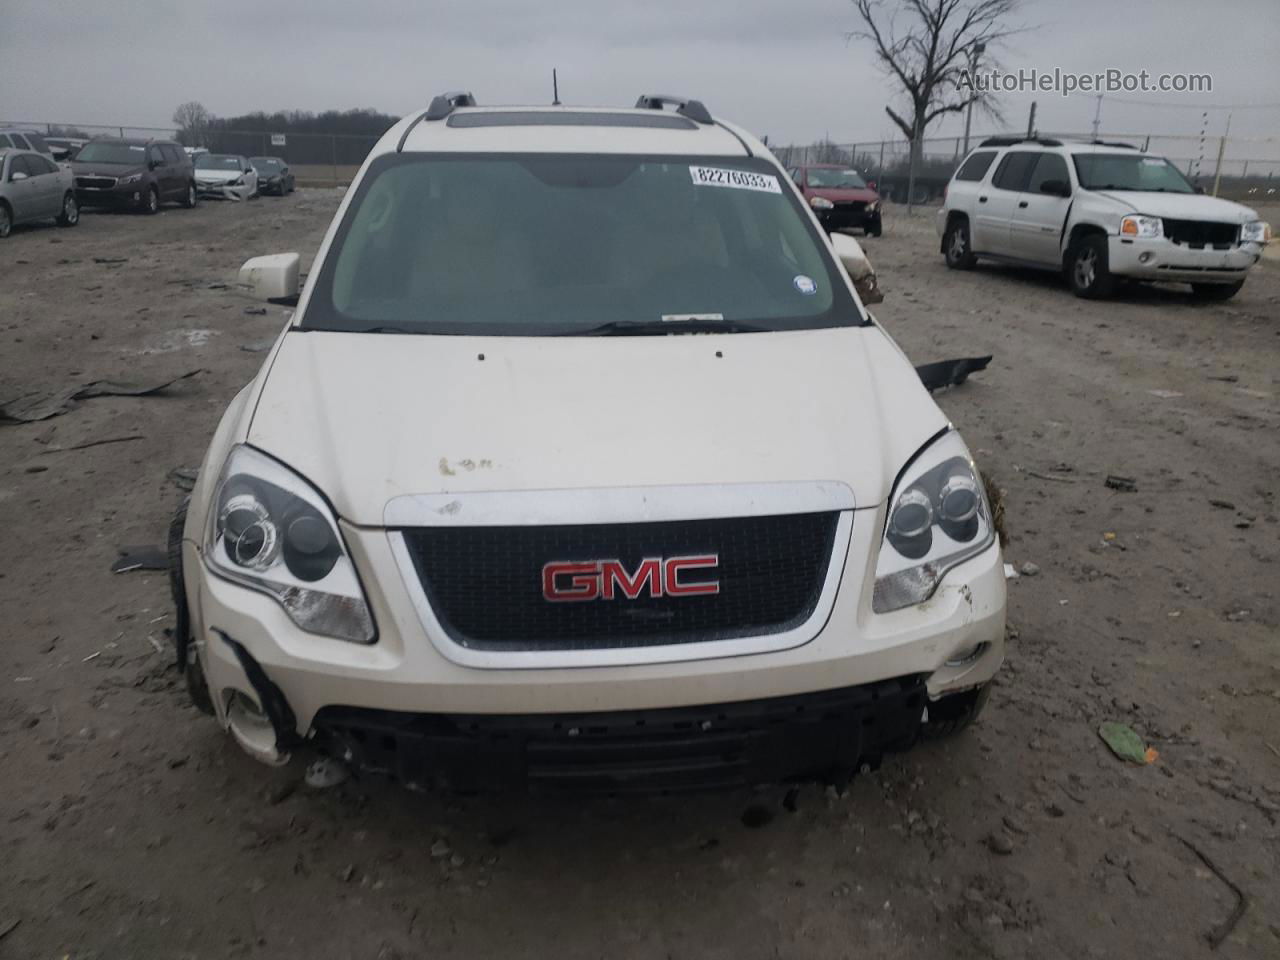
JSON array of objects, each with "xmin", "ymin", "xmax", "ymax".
[{"xmin": 0, "ymin": 120, "xmax": 379, "ymax": 187}]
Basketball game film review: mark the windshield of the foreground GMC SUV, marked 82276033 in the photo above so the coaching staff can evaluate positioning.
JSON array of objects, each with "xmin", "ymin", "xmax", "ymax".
[{"xmin": 302, "ymin": 154, "xmax": 863, "ymax": 335}]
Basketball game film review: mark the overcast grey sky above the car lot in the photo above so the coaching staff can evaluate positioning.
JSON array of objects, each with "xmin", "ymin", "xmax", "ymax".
[{"xmin": 0, "ymin": 0, "xmax": 1280, "ymax": 155}]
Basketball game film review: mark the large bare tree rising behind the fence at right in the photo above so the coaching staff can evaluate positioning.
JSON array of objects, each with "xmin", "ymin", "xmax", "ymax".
[{"xmin": 849, "ymin": 0, "xmax": 1020, "ymax": 205}]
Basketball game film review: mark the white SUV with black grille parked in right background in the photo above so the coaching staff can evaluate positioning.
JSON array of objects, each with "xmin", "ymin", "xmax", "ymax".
[{"xmin": 937, "ymin": 137, "xmax": 1271, "ymax": 300}]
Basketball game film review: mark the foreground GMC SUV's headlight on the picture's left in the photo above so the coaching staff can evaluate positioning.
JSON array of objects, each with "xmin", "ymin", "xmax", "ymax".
[{"xmin": 205, "ymin": 447, "xmax": 374, "ymax": 644}]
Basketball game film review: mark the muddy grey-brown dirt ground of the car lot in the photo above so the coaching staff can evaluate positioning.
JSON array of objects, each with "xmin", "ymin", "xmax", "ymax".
[{"xmin": 0, "ymin": 189, "xmax": 1280, "ymax": 960}]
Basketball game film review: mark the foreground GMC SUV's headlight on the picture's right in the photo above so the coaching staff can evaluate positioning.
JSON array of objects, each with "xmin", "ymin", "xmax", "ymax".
[{"xmin": 872, "ymin": 431, "xmax": 995, "ymax": 613}]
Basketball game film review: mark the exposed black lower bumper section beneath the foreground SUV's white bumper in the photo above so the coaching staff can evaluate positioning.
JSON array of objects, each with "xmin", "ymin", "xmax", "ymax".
[{"xmin": 315, "ymin": 677, "xmax": 928, "ymax": 794}]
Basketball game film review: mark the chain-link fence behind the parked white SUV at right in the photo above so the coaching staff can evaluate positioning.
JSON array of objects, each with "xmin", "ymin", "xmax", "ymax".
[{"xmin": 769, "ymin": 132, "xmax": 1280, "ymax": 204}]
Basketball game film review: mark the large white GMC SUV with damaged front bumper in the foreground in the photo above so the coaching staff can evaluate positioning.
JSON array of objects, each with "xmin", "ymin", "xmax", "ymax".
[{"xmin": 170, "ymin": 93, "xmax": 1005, "ymax": 791}]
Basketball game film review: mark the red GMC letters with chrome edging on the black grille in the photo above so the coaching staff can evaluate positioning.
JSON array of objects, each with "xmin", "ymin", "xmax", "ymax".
[{"xmin": 543, "ymin": 553, "xmax": 719, "ymax": 603}]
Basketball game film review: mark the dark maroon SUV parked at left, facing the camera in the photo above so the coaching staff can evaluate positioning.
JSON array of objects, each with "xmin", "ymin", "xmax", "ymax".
[{"xmin": 72, "ymin": 137, "xmax": 196, "ymax": 214}]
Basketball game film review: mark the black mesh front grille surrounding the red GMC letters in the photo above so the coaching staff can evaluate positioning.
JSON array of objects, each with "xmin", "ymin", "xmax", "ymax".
[{"xmin": 403, "ymin": 512, "xmax": 840, "ymax": 650}]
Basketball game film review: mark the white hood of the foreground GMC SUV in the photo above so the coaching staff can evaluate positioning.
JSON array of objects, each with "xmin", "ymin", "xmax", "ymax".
[{"xmin": 247, "ymin": 326, "xmax": 946, "ymax": 526}]
